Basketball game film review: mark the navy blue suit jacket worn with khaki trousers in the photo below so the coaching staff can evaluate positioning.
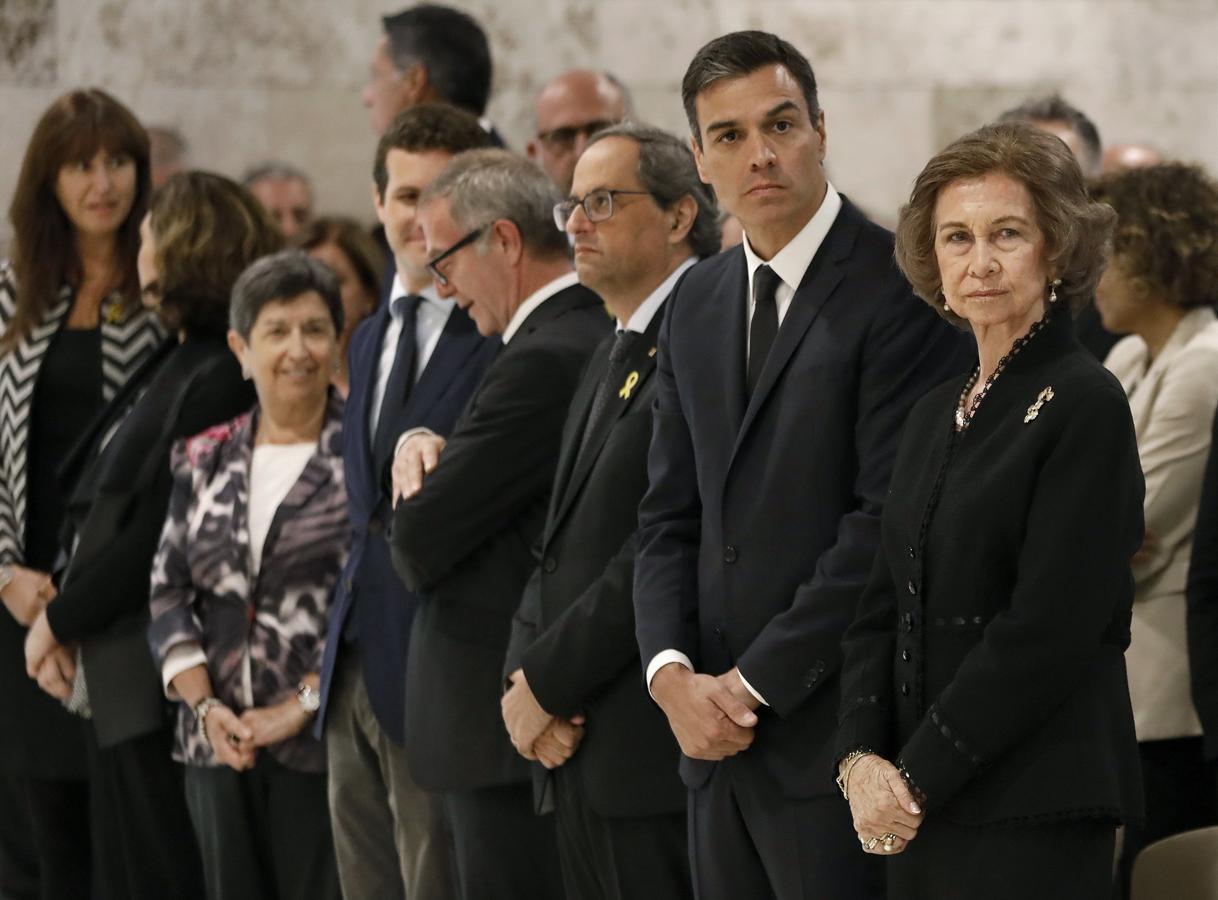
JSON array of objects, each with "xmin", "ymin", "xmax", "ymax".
[{"xmin": 315, "ymin": 302, "xmax": 501, "ymax": 743}]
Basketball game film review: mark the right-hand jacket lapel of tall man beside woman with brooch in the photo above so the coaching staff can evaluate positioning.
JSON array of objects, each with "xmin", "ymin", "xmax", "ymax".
[{"xmin": 732, "ymin": 197, "xmax": 860, "ymax": 458}]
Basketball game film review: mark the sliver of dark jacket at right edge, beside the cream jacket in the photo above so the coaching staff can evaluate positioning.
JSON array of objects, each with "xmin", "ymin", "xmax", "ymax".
[{"xmin": 1185, "ymin": 417, "xmax": 1218, "ymax": 759}]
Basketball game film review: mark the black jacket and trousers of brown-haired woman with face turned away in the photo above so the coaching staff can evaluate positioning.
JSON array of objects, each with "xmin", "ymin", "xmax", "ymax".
[{"xmin": 46, "ymin": 336, "xmax": 255, "ymax": 898}]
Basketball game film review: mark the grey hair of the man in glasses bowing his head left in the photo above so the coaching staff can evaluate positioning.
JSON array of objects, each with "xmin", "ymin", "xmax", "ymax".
[{"xmin": 419, "ymin": 150, "xmax": 571, "ymax": 257}]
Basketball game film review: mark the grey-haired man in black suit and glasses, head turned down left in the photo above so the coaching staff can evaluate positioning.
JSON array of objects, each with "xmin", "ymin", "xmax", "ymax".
[{"xmin": 392, "ymin": 150, "xmax": 609, "ymax": 900}]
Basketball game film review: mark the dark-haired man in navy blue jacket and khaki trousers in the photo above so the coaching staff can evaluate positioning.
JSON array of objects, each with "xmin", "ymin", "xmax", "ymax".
[{"xmin": 317, "ymin": 104, "xmax": 496, "ymax": 900}]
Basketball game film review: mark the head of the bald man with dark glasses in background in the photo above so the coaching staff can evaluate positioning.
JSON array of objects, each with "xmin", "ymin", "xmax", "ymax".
[{"xmin": 526, "ymin": 68, "xmax": 630, "ymax": 196}]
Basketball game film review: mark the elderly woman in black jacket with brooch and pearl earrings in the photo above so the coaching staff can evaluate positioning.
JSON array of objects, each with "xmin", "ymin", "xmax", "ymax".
[{"xmin": 838, "ymin": 124, "xmax": 1144, "ymax": 900}]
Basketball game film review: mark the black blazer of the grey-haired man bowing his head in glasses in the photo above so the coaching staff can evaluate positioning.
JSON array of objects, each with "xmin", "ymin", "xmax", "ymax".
[{"xmin": 391, "ymin": 285, "xmax": 609, "ymax": 790}]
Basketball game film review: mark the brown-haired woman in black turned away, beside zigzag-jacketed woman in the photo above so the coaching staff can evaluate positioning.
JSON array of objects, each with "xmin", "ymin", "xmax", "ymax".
[{"xmin": 26, "ymin": 172, "xmax": 283, "ymax": 900}]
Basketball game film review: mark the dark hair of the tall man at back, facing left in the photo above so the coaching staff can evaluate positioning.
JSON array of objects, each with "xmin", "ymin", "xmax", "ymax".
[{"xmin": 381, "ymin": 4, "xmax": 491, "ymax": 116}]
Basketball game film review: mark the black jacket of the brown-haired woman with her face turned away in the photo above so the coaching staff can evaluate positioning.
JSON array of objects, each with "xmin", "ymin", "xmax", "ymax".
[{"xmin": 46, "ymin": 337, "xmax": 255, "ymax": 748}]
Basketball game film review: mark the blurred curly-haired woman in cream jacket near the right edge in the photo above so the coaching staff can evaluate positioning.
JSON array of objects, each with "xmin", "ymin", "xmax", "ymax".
[{"xmin": 1095, "ymin": 163, "xmax": 1218, "ymax": 896}]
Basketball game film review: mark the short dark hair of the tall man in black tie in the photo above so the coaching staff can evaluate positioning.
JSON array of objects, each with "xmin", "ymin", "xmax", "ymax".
[{"xmin": 681, "ymin": 32, "xmax": 821, "ymax": 147}]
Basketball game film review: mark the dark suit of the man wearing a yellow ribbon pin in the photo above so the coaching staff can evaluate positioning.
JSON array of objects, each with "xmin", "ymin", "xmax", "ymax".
[{"xmin": 505, "ymin": 307, "xmax": 692, "ymax": 899}]
